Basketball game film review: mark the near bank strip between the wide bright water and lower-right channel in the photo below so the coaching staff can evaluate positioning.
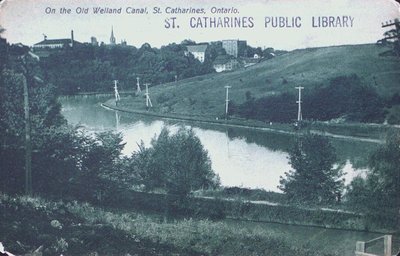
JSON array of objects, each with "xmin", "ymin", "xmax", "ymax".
[{"xmin": 102, "ymin": 186, "xmax": 397, "ymax": 233}]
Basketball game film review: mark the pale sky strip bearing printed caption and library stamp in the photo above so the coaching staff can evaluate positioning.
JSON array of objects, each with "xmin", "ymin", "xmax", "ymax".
[{"xmin": 0, "ymin": 0, "xmax": 400, "ymax": 50}]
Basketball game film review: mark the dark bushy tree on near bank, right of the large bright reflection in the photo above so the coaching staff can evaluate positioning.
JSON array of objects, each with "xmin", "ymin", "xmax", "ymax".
[{"xmin": 278, "ymin": 134, "xmax": 344, "ymax": 204}]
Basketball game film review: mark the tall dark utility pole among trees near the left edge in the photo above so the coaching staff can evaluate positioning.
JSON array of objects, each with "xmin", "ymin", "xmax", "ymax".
[{"xmin": 20, "ymin": 56, "xmax": 32, "ymax": 195}]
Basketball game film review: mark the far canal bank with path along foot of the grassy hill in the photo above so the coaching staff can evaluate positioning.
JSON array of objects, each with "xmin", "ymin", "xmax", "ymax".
[{"xmin": 101, "ymin": 97, "xmax": 400, "ymax": 144}]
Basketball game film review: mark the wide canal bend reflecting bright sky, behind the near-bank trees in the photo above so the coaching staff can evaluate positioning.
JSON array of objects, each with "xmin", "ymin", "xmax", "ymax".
[{"xmin": 61, "ymin": 96, "xmax": 377, "ymax": 192}]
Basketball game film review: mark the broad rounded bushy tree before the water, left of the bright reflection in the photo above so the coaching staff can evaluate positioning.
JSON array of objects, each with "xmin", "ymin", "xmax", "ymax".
[{"xmin": 136, "ymin": 128, "xmax": 219, "ymax": 198}]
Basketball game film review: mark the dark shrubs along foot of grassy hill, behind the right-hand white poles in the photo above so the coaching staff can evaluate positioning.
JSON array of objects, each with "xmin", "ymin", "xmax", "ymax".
[{"xmin": 232, "ymin": 75, "xmax": 400, "ymax": 123}]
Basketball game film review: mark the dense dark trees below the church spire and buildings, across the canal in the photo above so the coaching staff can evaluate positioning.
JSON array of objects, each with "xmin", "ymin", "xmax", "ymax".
[{"xmin": 40, "ymin": 40, "xmax": 284, "ymax": 95}]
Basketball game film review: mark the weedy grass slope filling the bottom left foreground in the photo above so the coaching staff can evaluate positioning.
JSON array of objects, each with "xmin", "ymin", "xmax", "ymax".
[{"xmin": 0, "ymin": 194, "xmax": 334, "ymax": 256}]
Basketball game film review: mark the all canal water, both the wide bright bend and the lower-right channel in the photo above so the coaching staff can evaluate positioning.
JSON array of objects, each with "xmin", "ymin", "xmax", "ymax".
[{"xmin": 61, "ymin": 96, "xmax": 399, "ymax": 256}]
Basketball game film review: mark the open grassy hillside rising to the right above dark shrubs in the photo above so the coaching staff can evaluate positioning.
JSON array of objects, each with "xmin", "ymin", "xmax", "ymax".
[{"xmin": 123, "ymin": 44, "xmax": 400, "ymax": 116}]
